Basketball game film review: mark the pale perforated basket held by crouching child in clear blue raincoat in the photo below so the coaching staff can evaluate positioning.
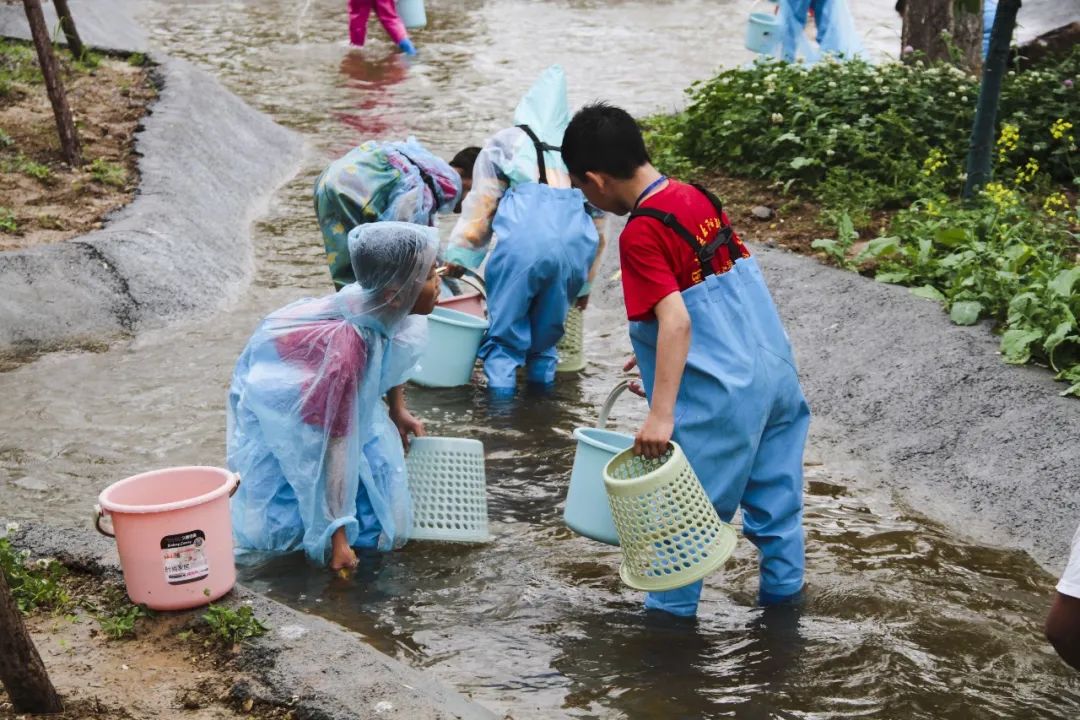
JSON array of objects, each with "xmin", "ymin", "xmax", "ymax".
[{"xmin": 405, "ymin": 437, "xmax": 491, "ymax": 543}]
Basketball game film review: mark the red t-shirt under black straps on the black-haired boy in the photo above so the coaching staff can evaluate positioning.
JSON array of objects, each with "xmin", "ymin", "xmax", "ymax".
[{"xmin": 619, "ymin": 180, "xmax": 750, "ymax": 321}]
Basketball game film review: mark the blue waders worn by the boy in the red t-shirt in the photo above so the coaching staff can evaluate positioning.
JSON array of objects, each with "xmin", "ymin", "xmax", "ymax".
[{"xmin": 630, "ymin": 205, "xmax": 810, "ymax": 616}]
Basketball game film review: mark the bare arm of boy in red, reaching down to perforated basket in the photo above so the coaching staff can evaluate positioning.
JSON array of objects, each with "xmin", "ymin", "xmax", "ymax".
[{"xmin": 634, "ymin": 293, "xmax": 690, "ymax": 458}]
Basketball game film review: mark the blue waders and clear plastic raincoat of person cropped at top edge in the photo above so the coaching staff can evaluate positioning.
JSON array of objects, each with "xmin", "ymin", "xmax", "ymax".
[{"xmin": 778, "ymin": 0, "xmax": 863, "ymax": 63}]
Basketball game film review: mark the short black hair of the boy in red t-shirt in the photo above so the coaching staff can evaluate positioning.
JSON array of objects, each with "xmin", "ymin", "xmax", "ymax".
[{"xmin": 563, "ymin": 103, "xmax": 649, "ymax": 180}]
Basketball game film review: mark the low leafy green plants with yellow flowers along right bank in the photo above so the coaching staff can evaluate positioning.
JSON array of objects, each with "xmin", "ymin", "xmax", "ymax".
[{"xmin": 855, "ymin": 197, "xmax": 1080, "ymax": 397}]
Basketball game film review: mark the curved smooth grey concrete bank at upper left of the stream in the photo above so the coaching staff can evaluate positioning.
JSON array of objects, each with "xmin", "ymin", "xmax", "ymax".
[{"xmin": 0, "ymin": 0, "xmax": 302, "ymax": 352}]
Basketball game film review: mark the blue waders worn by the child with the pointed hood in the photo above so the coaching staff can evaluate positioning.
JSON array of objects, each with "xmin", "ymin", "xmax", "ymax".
[{"xmin": 480, "ymin": 177, "xmax": 599, "ymax": 392}]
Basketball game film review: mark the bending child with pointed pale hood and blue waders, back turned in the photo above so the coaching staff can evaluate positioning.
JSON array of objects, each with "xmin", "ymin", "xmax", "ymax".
[{"xmin": 446, "ymin": 65, "xmax": 604, "ymax": 394}]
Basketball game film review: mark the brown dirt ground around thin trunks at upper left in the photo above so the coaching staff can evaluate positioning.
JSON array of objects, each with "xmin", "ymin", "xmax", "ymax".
[{"xmin": 0, "ymin": 40, "xmax": 157, "ymax": 250}]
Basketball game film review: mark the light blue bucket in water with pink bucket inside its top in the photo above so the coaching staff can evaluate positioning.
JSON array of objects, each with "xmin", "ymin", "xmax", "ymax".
[{"xmin": 410, "ymin": 308, "xmax": 488, "ymax": 388}]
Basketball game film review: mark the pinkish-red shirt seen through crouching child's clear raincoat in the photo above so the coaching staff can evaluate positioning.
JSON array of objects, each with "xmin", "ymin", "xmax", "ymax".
[{"xmin": 274, "ymin": 320, "xmax": 367, "ymax": 437}]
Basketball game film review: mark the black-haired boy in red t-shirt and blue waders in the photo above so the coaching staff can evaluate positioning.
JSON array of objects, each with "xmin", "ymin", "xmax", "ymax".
[{"xmin": 562, "ymin": 104, "xmax": 810, "ymax": 616}]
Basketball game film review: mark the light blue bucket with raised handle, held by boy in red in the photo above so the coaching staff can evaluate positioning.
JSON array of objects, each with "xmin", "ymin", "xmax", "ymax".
[{"xmin": 563, "ymin": 381, "xmax": 634, "ymax": 545}]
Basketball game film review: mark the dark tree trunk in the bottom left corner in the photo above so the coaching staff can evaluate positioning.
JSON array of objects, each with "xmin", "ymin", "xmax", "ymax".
[{"xmin": 0, "ymin": 572, "xmax": 64, "ymax": 712}]
